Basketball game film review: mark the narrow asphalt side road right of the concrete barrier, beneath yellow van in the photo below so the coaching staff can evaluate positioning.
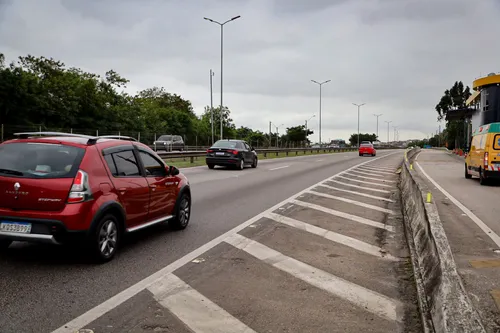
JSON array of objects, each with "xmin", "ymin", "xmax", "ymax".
[{"xmin": 416, "ymin": 150, "xmax": 500, "ymax": 333}]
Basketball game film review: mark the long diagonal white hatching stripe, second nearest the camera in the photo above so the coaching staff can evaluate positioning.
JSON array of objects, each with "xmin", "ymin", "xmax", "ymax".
[{"xmin": 225, "ymin": 234, "xmax": 401, "ymax": 321}]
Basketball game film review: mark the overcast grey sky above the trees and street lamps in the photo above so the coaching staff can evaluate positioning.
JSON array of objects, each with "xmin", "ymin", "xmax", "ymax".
[{"xmin": 0, "ymin": 0, "xmax": 500, "ymax": 141}]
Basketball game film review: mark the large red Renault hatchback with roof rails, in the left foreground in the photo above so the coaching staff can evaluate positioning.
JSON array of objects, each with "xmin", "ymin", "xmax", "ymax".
[{"xmin": 0, "ymin": 132, "xmax": 191, "ymax": 262}]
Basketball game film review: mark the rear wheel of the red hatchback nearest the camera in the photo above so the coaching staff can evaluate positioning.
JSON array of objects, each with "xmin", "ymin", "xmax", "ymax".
[{"xmin": 90, "ymin": 214, "xmax": 122, "ymax": 263}]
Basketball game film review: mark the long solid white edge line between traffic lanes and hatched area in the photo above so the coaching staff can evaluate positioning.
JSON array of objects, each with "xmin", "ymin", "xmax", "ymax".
[{"xmin": 52, "ymin": 152, "xmax": 399, "ymax": 333}]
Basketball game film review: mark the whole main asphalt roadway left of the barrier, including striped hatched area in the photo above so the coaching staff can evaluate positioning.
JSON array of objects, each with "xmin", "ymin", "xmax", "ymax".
[{"xmin": 0, "ymin": 151, "xmax": 418, "ymax": 333}]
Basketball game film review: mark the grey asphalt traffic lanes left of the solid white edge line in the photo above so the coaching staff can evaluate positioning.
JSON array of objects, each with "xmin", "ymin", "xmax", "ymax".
[{"xmin": 0, "ymin": 148, "xmax": 402, "ymax": 333}]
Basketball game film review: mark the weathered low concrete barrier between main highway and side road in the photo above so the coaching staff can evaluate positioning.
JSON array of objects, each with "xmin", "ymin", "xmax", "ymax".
[{"xmin": 400, "ymin": 149, "xmax": 486, "ymax": 333}]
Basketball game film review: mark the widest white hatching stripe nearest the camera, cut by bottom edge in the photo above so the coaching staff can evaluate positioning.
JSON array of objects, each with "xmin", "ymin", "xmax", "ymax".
[{"xmin": 148, "ymin": 274, "xmax": 255, "ymax": 333}]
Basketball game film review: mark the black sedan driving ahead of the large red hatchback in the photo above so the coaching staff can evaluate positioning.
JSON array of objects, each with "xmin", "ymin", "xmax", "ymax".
[{"xmin": 206, "ymin": 140, "xmax": 258, "ymax": 170}]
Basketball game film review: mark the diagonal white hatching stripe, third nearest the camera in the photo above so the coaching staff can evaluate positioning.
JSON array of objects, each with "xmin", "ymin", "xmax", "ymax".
[{"xmin": 266, "ymin": 213, "xmax": 398, "ymax": 261}]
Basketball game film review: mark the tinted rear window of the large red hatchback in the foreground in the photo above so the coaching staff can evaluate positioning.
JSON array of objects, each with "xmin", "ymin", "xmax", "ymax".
[{"xmin": 0, "ymin": 142, "xmax": 85, "ymax": 179}]
